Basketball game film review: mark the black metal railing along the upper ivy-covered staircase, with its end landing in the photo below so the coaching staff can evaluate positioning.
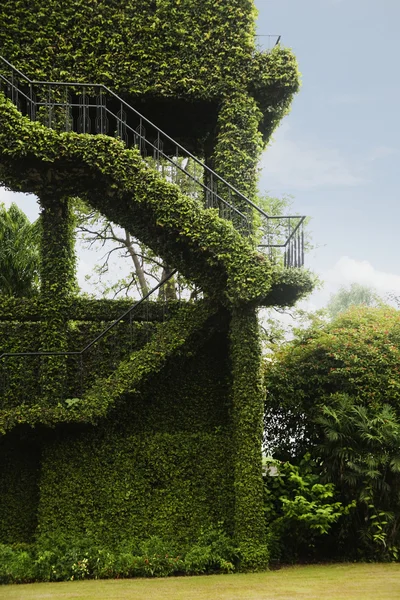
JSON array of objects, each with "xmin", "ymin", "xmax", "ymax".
[{"xmin": 0, "ymin": 57, "xmax": 305, "ymax": 267}]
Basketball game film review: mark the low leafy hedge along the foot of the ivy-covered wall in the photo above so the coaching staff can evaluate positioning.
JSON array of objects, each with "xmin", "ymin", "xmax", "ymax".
[{"xmin": 0, "ymin": 527, "xmax": 239, "ymax": 583}]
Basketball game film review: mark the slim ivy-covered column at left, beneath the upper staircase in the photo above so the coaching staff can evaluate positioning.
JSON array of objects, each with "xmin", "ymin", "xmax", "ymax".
[{"xmin": 39, "ymin": 195, "xmax": 76, "ymax": 404}]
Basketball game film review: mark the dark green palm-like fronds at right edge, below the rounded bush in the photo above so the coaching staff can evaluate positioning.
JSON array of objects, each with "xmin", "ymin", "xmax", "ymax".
[{"xmin": 317, "ymin": 394, "xmax": 400, "ymax": 560}]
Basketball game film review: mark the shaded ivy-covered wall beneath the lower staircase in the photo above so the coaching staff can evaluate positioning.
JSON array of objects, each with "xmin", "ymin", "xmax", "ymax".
[{"xmin": 35, "ymin": 333, "xmax": 234, "ymax": 544}]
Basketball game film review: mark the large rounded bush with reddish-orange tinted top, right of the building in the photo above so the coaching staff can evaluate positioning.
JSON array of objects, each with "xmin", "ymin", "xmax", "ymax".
[{"xmin": 265, "ymin": 307, "xmax": 400, "ymax": 458}]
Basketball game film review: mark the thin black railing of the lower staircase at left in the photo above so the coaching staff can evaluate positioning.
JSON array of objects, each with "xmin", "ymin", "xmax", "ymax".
[{"xmin": 0, "ymin": 269, "xmax": 177, "ymax": 408}]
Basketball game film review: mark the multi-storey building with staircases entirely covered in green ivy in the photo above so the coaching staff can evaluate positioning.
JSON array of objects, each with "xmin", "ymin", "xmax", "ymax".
[{"xmin": 0, "ymin": 0, "xmax": 312, "ymax": 567}]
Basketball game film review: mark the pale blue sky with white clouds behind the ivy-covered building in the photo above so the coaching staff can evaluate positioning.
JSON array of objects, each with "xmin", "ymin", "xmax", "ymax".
[{"xmin": 0, "ymin": 0, "xmax": 400, "ymax": 308}]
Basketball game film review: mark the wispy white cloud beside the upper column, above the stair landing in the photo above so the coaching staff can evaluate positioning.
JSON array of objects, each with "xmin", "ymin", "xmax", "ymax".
[{"xmin": 261, "ymin": 123, "xmax": 367, "ymax": 191}]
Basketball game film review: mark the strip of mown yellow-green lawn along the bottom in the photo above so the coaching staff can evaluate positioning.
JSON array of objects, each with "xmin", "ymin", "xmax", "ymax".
[{"xmin": 0, "ymin": 564, "xmax": 400, "ymax": 600}]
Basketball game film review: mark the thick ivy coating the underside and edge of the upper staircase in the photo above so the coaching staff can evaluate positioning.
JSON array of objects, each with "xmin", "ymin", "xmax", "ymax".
[{"xmin": 0, "ymin": 96, "xmax": 310, "ymax": 305}]
